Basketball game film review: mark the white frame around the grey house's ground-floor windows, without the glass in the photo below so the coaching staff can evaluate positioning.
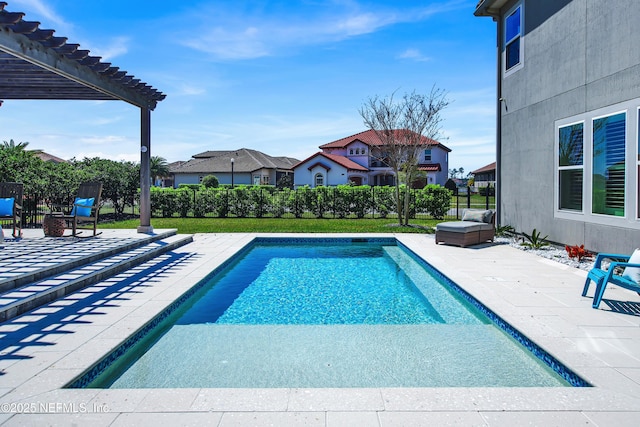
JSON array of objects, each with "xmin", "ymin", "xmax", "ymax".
[{"xmin": 553, "ymin": 98, "xmax": 640, "ymax": 227}]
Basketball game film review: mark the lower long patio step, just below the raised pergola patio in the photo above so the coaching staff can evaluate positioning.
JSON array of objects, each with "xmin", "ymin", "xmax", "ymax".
[{"xmin": 0, "ymin": 234, "xmax": 193, "ymax": 322}]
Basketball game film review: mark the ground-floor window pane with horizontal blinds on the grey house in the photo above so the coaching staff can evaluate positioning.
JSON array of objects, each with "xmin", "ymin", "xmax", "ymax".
[{"xmin": 591, "ymin": 113, "xmax": 626, "ymax": 216}]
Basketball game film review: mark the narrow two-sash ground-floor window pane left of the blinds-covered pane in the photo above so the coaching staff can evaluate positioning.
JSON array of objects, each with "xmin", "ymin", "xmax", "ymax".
[{"xmin": 558, "ymin": 123, "xmax": 584, "ymax": 212}]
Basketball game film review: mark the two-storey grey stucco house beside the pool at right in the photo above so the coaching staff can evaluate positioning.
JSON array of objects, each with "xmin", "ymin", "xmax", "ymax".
[{"xmin": 475, "ymin": 0, "xmax": 640, "ymax": 253}]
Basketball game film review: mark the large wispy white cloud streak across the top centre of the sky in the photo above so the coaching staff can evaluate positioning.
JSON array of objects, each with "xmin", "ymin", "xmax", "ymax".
[{"xmin": 176, "ymin": 1, "xmax": 468, "ymax": 60}]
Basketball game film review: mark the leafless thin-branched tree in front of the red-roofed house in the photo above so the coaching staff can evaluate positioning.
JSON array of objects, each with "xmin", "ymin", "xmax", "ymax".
[{"xmin": 359, "ymin": 87, "xmax": 449, "ymax": 225}]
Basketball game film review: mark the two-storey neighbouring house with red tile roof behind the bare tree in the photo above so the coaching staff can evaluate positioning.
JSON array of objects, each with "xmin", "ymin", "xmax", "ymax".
[{"xmin": 294, "ymin": 130, "xmax": 451, "ymax": 187}]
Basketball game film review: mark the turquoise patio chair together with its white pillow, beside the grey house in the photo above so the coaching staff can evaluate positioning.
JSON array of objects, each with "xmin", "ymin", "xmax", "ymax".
[{"xmin": 582, "ymin": 249, "xmax": 640, "ymax": 308}]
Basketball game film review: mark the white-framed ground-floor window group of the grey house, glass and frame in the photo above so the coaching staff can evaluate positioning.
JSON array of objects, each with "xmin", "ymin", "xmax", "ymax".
[{"xmin": 554, "ymin": 102, "xmax": 640, "ymax": 225}]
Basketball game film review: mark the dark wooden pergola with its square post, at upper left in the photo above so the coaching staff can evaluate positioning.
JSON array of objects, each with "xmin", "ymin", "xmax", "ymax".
[{"xmin": 0, "ymin": 1, "xmax": 166, "ymax": 233}]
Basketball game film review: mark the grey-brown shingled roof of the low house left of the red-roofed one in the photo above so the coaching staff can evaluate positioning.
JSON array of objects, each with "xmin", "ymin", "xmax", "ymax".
[{"xmin": 169, "ymin": 148, "xmax": 298, "ymax": 174}]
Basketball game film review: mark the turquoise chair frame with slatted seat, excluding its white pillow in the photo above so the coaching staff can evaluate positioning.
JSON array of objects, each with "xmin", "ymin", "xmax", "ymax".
[{"xmin": 582, "ymin": 253, "xmax": 640, "ymax": 308}]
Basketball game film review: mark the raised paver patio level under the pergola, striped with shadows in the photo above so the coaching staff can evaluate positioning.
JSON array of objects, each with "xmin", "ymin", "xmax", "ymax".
[{"xmin": 0, "ymin": 229, "xmax": 176, "ymax": 294}]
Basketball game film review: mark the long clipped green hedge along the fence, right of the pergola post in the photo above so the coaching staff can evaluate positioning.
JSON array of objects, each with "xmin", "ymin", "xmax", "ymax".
[{"xmin": 151, "ymin": 185, "xmax": 451, "ymax": 219}]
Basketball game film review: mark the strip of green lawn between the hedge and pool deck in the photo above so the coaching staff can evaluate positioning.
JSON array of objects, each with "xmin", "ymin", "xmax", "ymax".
[{"xmin": 99, "ymin": 218, "xmax": 441, "ymax": 234}]
